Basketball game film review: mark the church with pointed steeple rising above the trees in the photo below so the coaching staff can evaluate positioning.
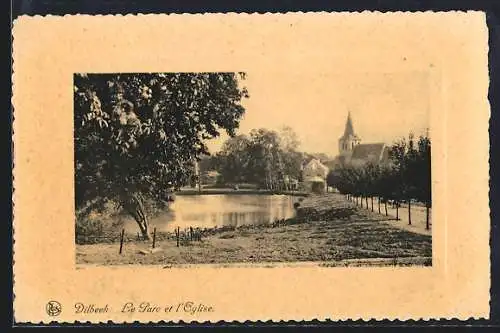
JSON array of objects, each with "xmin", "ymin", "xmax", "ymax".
[{"xmin": 329, "ymin": 112, "xmax": 389, "ymax": 169}]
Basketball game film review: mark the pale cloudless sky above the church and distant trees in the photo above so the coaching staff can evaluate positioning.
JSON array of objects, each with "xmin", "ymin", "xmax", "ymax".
[{"xmin": 207, "ymin": 67, "xmax": 430, "ymax": 156}]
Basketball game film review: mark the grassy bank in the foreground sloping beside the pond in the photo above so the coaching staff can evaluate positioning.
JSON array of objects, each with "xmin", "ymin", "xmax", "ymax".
[{"xmin": 76, "ymin": 194, "xmax": 432, "ymax": 266}]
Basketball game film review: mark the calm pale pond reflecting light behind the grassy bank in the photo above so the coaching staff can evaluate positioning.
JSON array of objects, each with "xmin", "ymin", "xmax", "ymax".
[{"xmin": 125, "ymin": 194, "xmax": 299, "ymax": 234}]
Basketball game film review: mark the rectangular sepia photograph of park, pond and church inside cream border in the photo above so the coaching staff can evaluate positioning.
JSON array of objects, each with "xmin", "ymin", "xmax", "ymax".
[{"xmin": 74, "ymin": 69, "xmax": 432, "ymax": 266}]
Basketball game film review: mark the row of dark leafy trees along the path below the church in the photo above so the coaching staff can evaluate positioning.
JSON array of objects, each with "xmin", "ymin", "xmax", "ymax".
[{"xmin": 327, "ymin": 134, "xmax": 432, "ymax": 228}]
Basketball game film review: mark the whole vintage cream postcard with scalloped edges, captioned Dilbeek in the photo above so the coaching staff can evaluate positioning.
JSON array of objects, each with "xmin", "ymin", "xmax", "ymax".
[{"xmin": 13, "ymin": 12, "xmax": 490, "ymax": 323}]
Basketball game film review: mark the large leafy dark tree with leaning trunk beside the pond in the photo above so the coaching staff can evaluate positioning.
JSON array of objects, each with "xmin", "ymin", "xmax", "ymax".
[{"xmin": 74, "ymin": 73, "xmax": 248, "ymax": 238}]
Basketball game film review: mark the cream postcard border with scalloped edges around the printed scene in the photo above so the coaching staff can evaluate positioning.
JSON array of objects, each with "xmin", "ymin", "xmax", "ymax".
[{"xmin": 13, "ymin": 12, "xmax": 490, "ymax": 323}]
